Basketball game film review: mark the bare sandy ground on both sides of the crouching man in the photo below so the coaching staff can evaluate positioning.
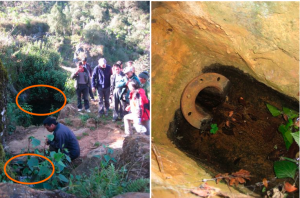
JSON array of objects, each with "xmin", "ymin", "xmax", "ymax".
[{"xmin": 5, "ymin": 99, "xmax": 124, "ymax": 158}]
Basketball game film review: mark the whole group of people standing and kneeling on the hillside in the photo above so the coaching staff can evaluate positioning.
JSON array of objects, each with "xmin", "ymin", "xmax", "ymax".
[{"xmin": 71, "ymin": 58, "xmax": 150, "ymax": 135}]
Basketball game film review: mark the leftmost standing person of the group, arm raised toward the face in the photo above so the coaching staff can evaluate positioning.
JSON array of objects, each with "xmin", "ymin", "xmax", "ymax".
[{"xmin": 71, "ymin": 62, "xmax": 91, "ymax": 112}]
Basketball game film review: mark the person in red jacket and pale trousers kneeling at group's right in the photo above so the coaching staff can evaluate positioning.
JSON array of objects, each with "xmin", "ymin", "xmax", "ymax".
[{"xmin": 124, "ymin": 81, "xmax": 150, "ymax": 135}]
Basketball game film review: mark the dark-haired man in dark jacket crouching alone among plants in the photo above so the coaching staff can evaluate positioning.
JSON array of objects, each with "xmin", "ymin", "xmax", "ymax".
[{"xmin": 43, "ymin": 117, "xmax": 80, "ymax": 160}]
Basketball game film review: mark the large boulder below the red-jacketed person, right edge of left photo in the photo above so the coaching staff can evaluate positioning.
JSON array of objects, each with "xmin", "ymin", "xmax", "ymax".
[{"xmin": 119, "ymin": 134, "xmax": 150, "ymax": 180}]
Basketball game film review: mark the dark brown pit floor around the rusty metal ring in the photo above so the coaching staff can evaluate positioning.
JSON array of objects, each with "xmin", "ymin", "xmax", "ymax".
[{"xmin": 167, "ymin": 65, "xmax": 299, "ymax": 196}]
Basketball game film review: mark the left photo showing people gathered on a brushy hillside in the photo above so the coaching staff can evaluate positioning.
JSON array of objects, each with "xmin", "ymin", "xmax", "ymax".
[{"xmin": 0, "ymin": 1, "xmax": 151, "ymax": 198}]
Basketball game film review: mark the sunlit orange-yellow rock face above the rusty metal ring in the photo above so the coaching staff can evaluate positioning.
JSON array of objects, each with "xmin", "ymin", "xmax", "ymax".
[{"xmin": 152, "ymin": 2, "xmax": 299, "ymax": 143}]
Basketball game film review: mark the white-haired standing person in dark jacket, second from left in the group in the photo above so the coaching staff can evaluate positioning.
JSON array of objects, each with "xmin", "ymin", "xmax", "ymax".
[{"xmin": 92, "ymin": 58, "xmax": 112, "ymax": 117}]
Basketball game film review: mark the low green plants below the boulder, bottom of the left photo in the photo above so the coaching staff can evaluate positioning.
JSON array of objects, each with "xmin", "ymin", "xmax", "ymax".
[{"xmin": 67, "ymin": 146, "xmax": 149, "ymax": 198}]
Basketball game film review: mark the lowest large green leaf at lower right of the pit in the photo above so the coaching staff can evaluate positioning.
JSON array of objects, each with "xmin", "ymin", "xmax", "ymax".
[{"xmin": 274, "ymin": 161, "xmax": 298, "ymax": 179}]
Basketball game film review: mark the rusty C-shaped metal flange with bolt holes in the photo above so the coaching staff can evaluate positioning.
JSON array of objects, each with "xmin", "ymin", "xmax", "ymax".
[{"xmin": 180, "ymin": 73, "xmax": 230, "ymax": 129}]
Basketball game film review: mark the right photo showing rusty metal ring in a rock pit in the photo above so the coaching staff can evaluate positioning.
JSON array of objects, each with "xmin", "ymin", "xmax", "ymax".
[{"xmin": 151, "ymin": 1, "xmax": 299, "ymax": 198}]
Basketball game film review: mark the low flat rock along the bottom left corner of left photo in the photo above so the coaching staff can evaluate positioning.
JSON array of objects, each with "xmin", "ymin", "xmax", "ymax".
[{"xmin": 0, "ymin": 183, "xmax": 76, "ymax": 198}]
